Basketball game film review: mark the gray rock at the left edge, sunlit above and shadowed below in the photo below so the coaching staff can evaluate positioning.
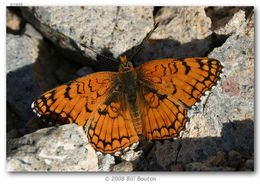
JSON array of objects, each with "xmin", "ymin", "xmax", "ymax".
[{"xmin": 6, "ymin": 25, "xmax": 42, "ymax": 124}]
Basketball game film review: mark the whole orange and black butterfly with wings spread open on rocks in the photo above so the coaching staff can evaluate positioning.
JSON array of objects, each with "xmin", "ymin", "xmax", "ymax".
[{"xmin": 32, "ymin": 23, "xmax": 223, "ymax": 153}]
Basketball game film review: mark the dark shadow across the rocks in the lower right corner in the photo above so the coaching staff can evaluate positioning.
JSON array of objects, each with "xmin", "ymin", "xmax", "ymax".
[{"xmin": 133, "ymin": 119, "xmax": 254, "ymax": 171}]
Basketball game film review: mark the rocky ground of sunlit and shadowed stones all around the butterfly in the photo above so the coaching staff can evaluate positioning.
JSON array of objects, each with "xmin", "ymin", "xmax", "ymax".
[{"xmin": 6, "ymin": 6, "xmax": 254, "ymax": 171}]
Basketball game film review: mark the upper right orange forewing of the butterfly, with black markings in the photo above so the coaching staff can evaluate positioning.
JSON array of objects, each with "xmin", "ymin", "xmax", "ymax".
[{"xmin": 137, "ymin": 58, "xmax": 223, "ymax": 108}]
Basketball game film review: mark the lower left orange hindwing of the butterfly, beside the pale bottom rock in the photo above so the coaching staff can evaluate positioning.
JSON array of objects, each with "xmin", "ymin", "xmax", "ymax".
[{"xmin": 88, "ymin": 92, "xmax": 138, "ymax": 153}]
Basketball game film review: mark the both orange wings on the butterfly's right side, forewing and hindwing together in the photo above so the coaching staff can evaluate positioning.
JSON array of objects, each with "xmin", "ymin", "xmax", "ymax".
[{"xmin": 136, "ymin": 58, "xmax": 223, "ymax": 139}]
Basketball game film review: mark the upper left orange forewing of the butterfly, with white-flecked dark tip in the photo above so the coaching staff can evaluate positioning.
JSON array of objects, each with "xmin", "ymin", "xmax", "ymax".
[{"xmin": 32, "ymin": 72, "xmax": 117, "ymax": 127}]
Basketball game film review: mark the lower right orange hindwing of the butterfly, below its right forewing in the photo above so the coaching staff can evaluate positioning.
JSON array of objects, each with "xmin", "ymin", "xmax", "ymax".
[{"xmin": 140, "ymin": 85, "xmax": 188, "ymax": 140}]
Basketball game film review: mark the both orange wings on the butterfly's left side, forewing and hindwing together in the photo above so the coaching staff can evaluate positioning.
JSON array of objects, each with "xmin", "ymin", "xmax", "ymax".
[{"xmin": 32, "ymin": 72, "xmax": 138, "ymax": 153}]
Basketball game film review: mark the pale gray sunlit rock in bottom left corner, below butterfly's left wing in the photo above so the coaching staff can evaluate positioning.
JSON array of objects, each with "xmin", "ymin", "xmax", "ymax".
[{"xmin": 6, "ymin": 124, "xmax": 98, "ymax": 172}]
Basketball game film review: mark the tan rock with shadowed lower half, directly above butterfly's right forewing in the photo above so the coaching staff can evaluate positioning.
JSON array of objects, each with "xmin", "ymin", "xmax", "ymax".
[{"xmin": 129, "ymin": 7, "xmax": 226, "ymax": 65}]
